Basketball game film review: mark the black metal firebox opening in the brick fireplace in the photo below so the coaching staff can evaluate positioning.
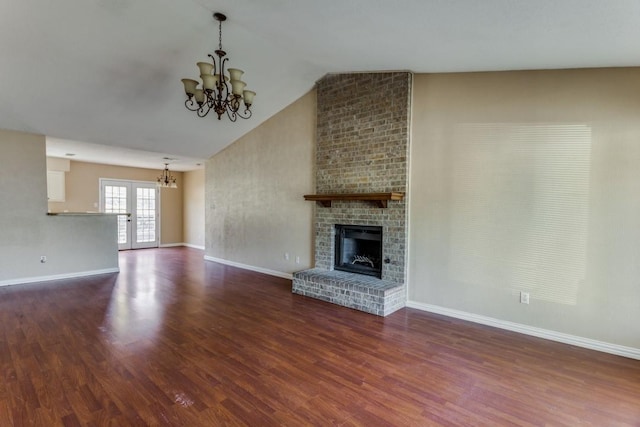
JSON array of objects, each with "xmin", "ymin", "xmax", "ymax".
[{"xmin": 334, "ymin": 224, "xmax": 382, "ymax": 278}]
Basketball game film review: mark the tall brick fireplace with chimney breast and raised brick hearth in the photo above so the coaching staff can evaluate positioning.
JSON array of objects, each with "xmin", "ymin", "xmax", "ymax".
[{"xmin": 293, "ymin": 72, "xmax": 412, "ymax": 316}]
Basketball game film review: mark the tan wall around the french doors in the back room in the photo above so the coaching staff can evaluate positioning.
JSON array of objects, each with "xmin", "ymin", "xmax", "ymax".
[{"xmin": 49, "ymin": 161, "xmax": 183, "ymax": 245}]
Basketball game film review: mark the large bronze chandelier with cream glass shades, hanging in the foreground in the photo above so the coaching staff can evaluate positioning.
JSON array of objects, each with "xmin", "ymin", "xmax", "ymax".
[{"xmin": 182, "ymin": 12, "xmax": 256, "ymax": 122}]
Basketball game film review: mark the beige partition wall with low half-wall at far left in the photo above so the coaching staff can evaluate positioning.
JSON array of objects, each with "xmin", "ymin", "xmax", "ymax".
[{"xmin": 0, "ymin": 130, "xmax": 118, "ymax": 285}]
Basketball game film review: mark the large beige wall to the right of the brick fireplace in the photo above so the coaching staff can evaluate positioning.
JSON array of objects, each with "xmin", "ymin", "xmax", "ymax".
[{"xmin": 409, "ymin": 68, "xmax": 640, "ymax": 348}]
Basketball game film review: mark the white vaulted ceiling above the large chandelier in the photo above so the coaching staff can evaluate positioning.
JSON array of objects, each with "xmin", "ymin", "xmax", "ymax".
[{"xmin": 0, "ymin": 0, "xmax": 640, "ymax": 170}]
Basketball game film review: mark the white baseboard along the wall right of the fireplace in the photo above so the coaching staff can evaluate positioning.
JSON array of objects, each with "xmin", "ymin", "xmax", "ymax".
[{"xmin": 406, "ymin": 301, "xmax": 640, "ymax": 360}]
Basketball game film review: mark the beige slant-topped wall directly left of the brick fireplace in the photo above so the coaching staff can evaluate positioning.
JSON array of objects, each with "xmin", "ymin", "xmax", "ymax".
[{"xmin": 205, "ymin": 91, "xmax": 316, "ymax": 273}]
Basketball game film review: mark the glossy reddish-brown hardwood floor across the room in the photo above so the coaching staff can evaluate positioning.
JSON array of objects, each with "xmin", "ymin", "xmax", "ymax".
[{"xmin": 0, "ymin": 248, "xmax": 640, "ymax": 426}]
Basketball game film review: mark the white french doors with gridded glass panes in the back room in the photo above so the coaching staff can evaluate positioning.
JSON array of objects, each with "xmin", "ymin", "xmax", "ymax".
[{"xmin": 100, "ymin": 179, "xmax": 160, "ymax": 250}]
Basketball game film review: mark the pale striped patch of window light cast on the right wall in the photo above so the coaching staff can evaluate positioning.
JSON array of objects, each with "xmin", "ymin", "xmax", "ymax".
[{"xmin": 448, "ymin": 123, "xmax": 591, "ymax": 304}]
